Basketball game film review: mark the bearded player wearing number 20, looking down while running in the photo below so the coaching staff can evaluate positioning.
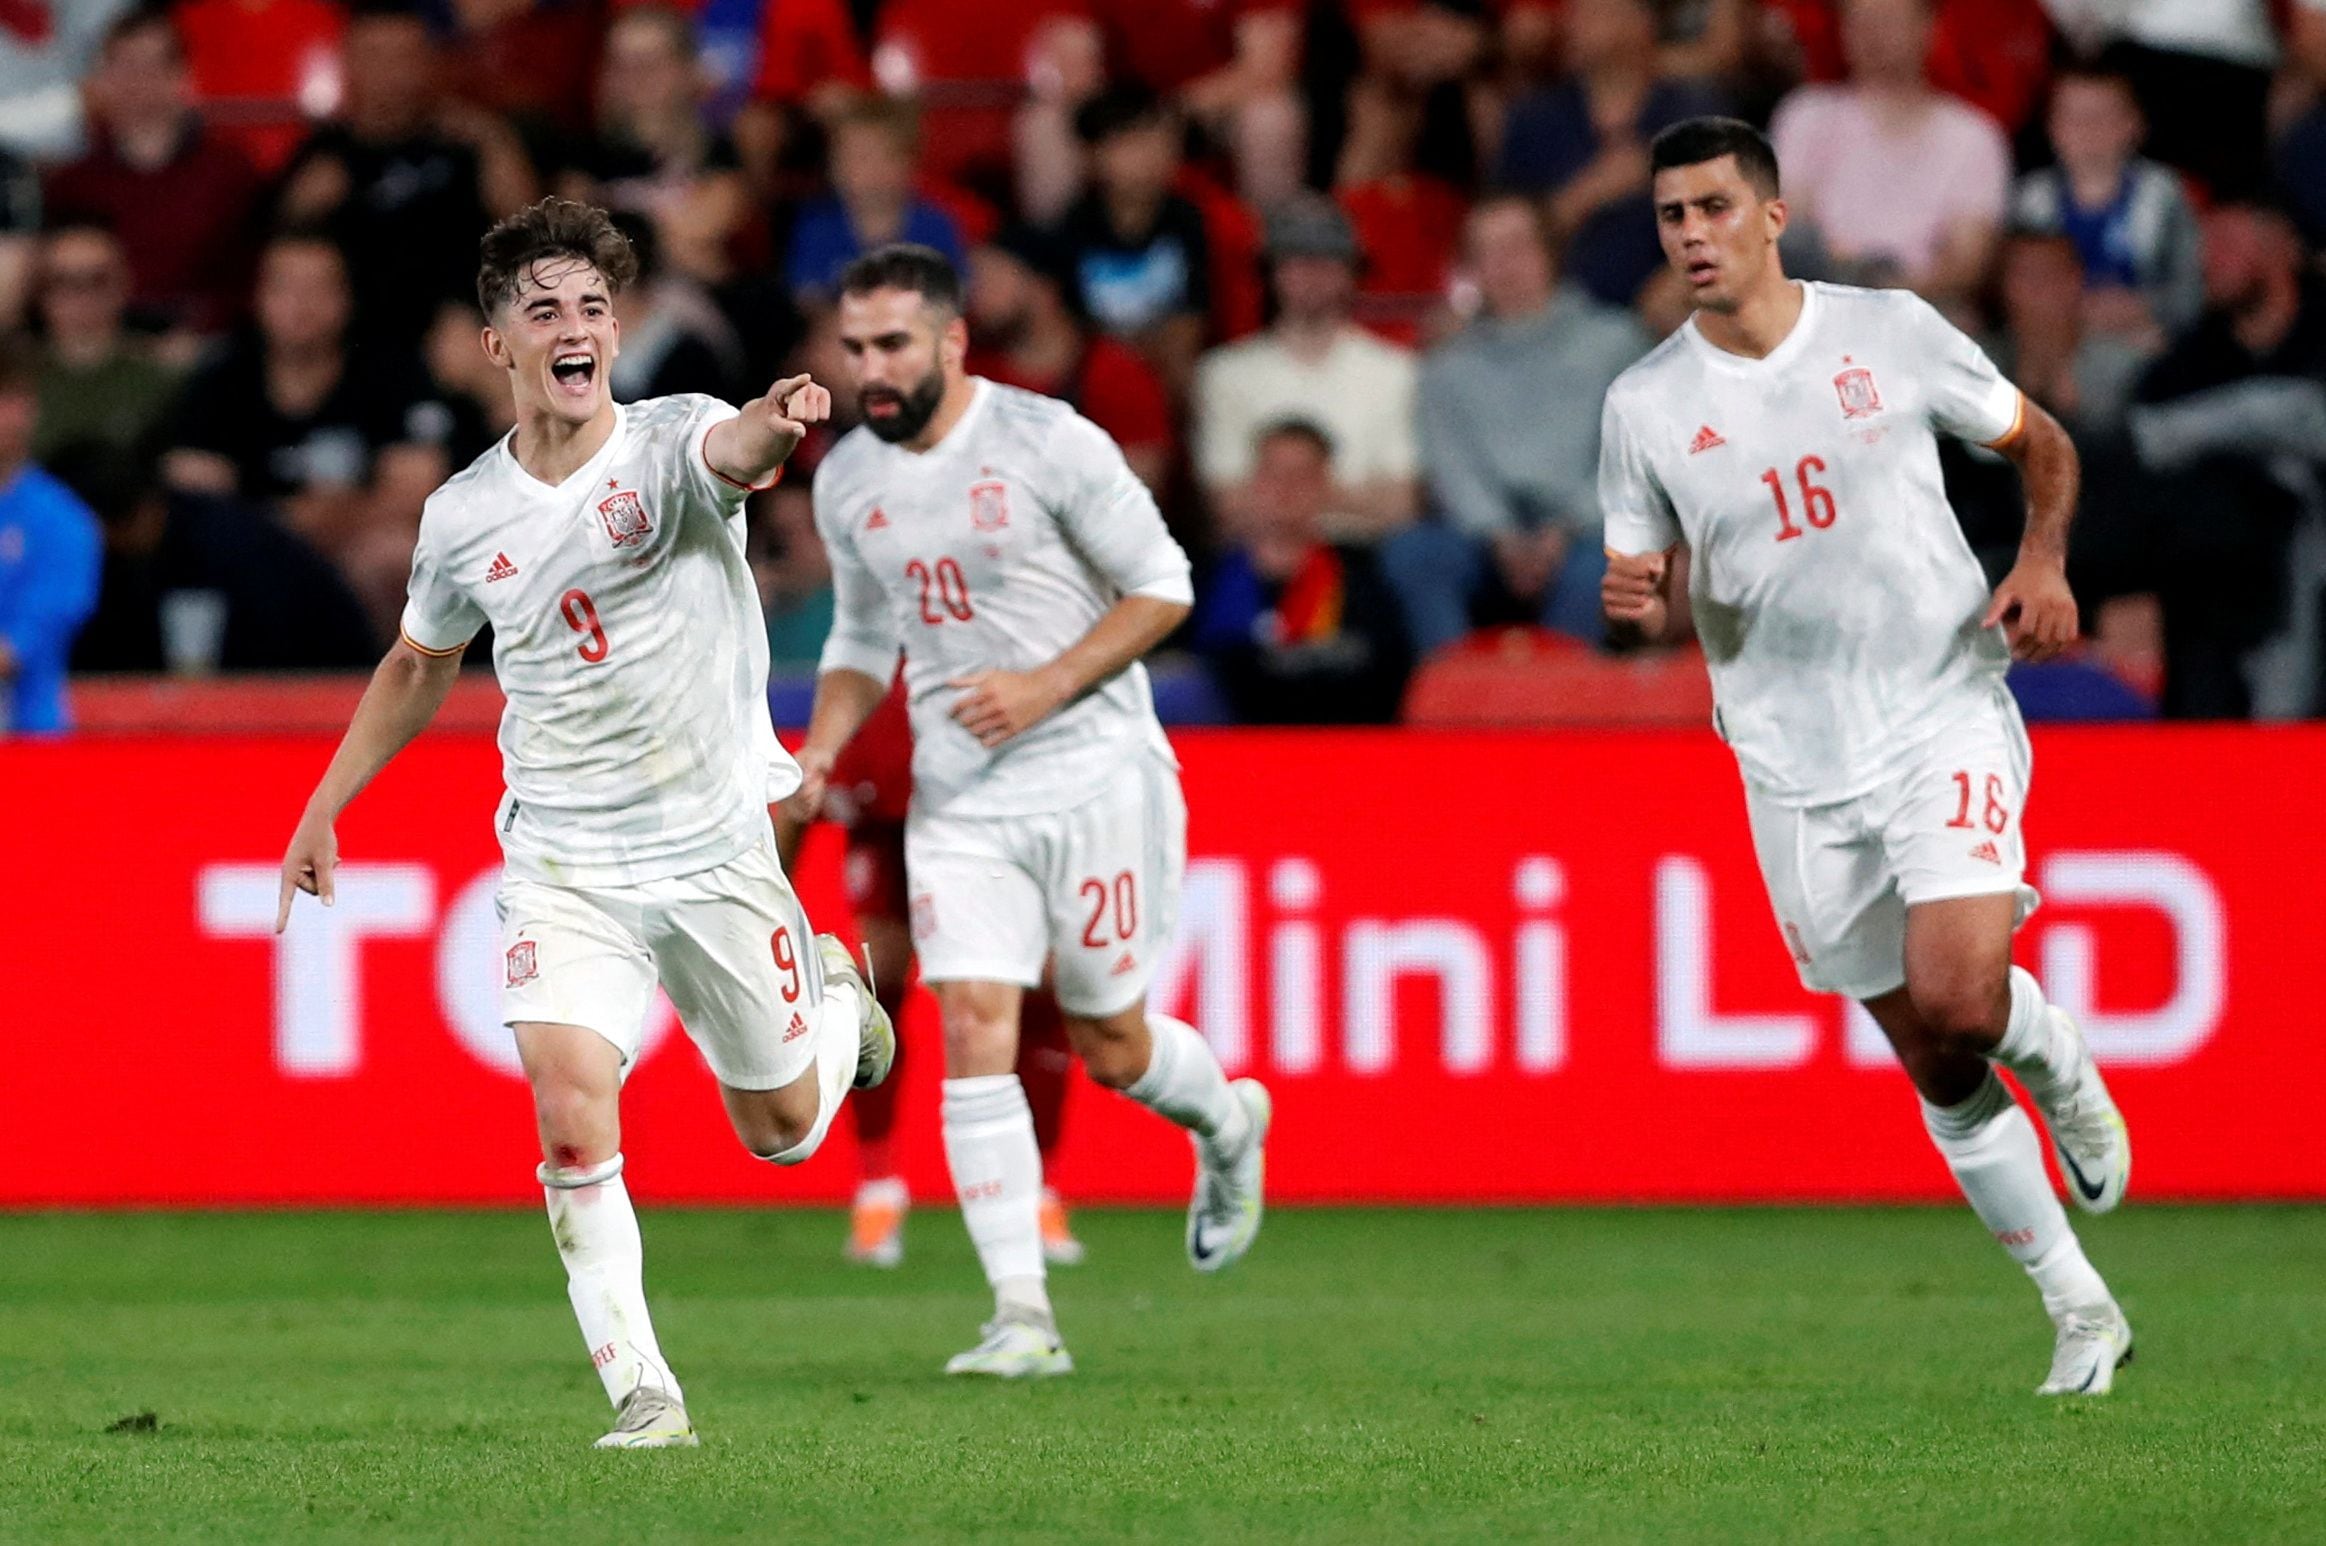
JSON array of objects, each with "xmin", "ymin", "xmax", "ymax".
[{"xmin": 800, "ymin": 246, "xmax": 1270, "ymax": 1379}]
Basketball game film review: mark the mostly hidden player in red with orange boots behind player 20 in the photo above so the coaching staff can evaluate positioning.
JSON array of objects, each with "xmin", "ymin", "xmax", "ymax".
[{"xmin": 777, "ymin": 677, "xmax": 1084, "ymax": 1267}]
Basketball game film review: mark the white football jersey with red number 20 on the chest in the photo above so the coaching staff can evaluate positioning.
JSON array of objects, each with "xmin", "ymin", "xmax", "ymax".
[{"xmin": 816, "ymin": 379, "xmax": 1193, "ymax": 816}]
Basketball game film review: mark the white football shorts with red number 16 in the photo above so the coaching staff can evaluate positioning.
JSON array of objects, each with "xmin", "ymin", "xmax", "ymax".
[{"xmin": 1745, "ymin": 686, "xmax": 2040, "ymax": 1000}]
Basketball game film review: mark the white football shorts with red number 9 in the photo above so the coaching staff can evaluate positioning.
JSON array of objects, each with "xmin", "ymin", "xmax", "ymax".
[{"xmin": 498, "ymin": 830, "xmax": 823, "ymax": 1090}]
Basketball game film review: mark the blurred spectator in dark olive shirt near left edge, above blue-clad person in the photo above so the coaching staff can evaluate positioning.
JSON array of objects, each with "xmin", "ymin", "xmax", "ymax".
[{"xmin": 33, "ymin": 223, "xmax": 177, "ymax": 463}]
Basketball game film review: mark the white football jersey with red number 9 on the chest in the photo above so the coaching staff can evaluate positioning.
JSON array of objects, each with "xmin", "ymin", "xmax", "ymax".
[{"xmin": 402, "ymin": 395, "xmax": 800, "ymax": 886}]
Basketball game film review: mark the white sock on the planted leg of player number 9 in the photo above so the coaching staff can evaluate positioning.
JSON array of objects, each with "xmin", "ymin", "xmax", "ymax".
[{"xmin": 535, "ymin": 1153, "xmax": 684, "ymax": 1407}]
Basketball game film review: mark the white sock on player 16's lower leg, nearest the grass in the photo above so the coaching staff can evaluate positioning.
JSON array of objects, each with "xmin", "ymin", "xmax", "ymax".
[{"xmin": 1921, "ymin": 1074, "xmax": 2110, "ymax": 1320}]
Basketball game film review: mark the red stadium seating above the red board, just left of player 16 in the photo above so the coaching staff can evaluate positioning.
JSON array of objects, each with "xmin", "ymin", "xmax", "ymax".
[{"xmin": 1405, "ymin": 628, "xmax": 1712, "ymax": 725}]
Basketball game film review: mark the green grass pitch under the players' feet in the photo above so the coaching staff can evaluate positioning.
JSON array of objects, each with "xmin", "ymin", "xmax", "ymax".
[{"xmin": 0, "ymin": 1207, "xmax": 2326, "ymax": 1546}]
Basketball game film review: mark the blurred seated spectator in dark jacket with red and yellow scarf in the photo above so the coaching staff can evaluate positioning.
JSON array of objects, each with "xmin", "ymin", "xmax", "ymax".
[{"xmin": 1189, "ymin": 418, "xmax": 1412, "ymax": 725}]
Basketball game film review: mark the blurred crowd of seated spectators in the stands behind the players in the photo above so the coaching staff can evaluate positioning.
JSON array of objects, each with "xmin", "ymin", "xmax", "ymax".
[{"xmin": 0, "ymin": 0, "xmax": 2326, "ymax": 730}]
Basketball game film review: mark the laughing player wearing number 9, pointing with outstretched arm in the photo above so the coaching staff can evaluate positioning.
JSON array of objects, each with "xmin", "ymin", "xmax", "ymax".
[{"xmin": 277, "ymin": 200, "xmax": 896, "ymax": 1448}]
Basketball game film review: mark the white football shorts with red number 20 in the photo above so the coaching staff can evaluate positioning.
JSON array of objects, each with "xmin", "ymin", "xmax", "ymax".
[{"xmin": 905, "ymin": 751, "xmax": 1186, "ymax": 1018}]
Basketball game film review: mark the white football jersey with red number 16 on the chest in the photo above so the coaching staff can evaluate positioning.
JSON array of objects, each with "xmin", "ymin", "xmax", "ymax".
[{"xmin": 1600, "ymin": 284, "xmax": 2024, "ymax": 804}]
